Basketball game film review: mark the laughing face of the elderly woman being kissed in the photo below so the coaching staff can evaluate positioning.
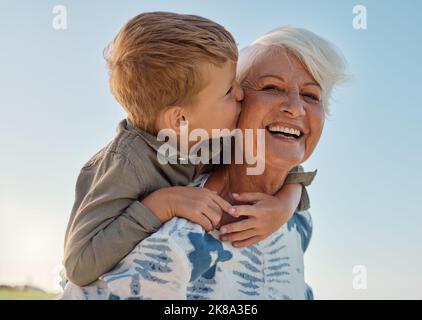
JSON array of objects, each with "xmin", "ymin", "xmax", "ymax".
[{"xmin": 238, "ymin": 49, "xmax": 325, "ymax": 169}]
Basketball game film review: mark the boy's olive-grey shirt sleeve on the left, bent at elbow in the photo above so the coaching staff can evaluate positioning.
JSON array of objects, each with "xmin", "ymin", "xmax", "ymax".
[{"xmin": 64, "ymin": 153, "xmax": 161, "ymax": 286}]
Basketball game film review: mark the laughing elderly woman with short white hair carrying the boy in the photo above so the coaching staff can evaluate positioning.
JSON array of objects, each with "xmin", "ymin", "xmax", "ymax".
[{"xmin": 64, "ymin": 28, "xmax": 344, "ymax": 299}]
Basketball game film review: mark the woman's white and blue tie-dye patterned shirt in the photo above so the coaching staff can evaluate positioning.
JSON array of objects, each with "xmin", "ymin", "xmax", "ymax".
[{"xmin": 62, "ymin": 179, "xmax": 313, "ymax": 299}]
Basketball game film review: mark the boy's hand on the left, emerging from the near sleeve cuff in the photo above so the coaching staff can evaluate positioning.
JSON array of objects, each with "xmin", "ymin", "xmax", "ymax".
[{"xmin": 142, "ymin": 187, "xmax": 234, "ymax": 231}]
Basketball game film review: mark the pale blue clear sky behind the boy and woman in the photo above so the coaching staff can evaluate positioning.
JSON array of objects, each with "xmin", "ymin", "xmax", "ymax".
[{"xmin": 0, "ymin": 0, "xmax": 422, "ymax": 299}]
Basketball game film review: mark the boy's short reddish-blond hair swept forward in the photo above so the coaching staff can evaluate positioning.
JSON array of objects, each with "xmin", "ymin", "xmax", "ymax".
[{"xmin": 104, "ymin": 12, "xmax": 238, "ymax": 133}]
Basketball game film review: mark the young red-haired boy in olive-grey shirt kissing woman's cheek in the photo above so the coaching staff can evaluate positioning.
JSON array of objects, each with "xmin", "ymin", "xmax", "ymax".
[{"xmin": 64, "ymin": 12, "xmax": 313, "ymax": 286}]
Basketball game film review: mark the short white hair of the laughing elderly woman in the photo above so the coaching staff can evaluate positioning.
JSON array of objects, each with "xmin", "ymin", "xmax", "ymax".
[{"xmin": 237, "ymin": 27, "xmax": 347, "ymax": 114}]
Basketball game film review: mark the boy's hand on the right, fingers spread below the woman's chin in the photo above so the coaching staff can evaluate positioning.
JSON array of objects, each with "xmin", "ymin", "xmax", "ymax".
[{"xmin": 220, "ymin": 185, "xmax": 301, "ymax": 248}]
